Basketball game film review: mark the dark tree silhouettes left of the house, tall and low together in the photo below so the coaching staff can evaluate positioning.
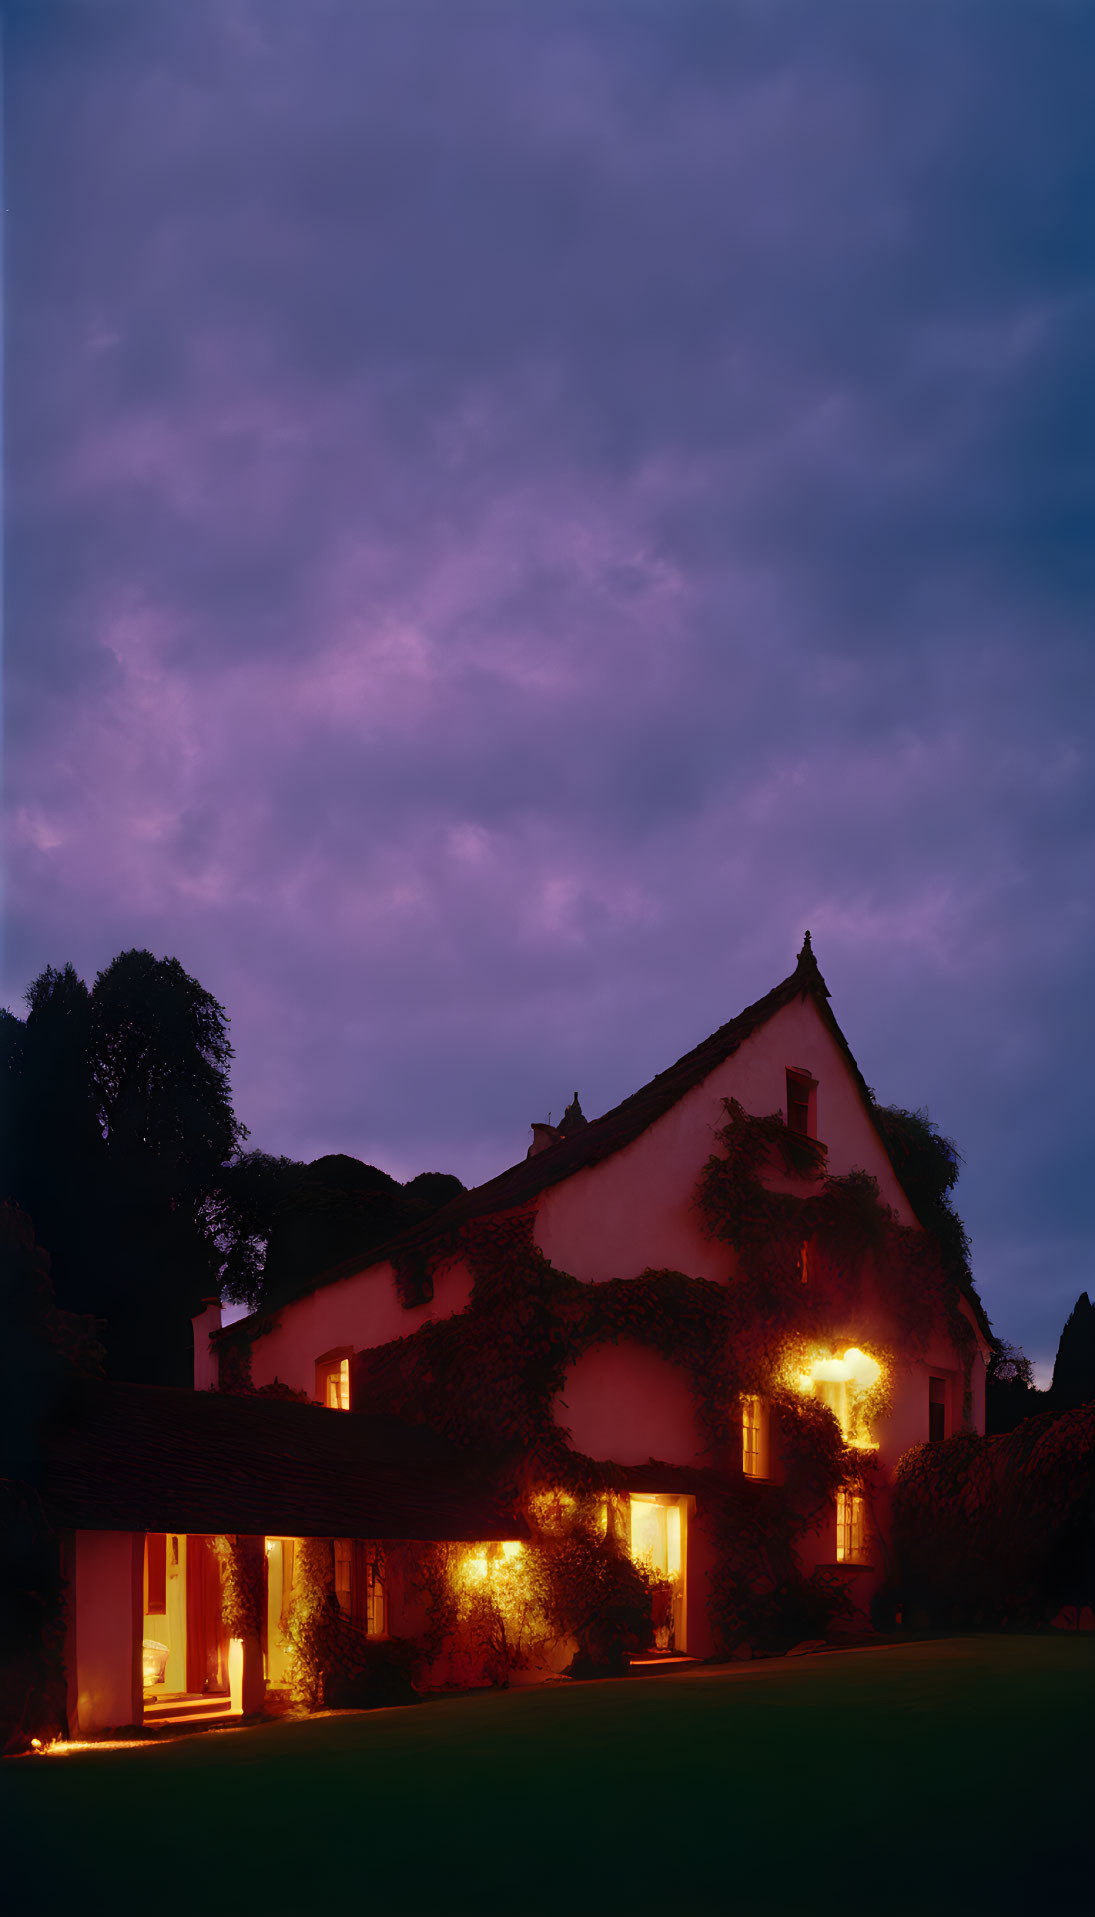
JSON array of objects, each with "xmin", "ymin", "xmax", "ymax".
[{"xmin": 0, "ymin": 951, "xmax": 462, "ymax": 1384}]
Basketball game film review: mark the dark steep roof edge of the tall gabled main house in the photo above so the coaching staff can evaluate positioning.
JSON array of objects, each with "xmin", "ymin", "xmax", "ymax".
[{"xmin": 227, "ymin": 932, "xmax": 874, "ymax": 1338}]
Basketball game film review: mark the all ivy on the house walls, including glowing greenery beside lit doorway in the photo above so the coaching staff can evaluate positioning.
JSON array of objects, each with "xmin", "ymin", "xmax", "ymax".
[{"xmin": 218, "ymin": 1100, "xmax": 976, "ymax": 1697}]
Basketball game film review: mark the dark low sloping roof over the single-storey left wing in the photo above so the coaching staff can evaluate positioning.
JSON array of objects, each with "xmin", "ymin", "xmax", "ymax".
[{"xmin": 35, "ymin": 1378, "xmax": 524, "ymax": 1543}]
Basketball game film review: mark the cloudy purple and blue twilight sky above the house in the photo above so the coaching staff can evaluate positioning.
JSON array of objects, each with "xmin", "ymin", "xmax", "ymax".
[{"xmin": 2, "ymin": 0, "xmax": 1095, "ymax": 1363}]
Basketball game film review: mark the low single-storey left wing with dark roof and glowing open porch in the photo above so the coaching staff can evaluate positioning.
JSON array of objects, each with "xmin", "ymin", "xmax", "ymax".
[{"xmin": 36, "ymin": 1376, "xmax": 525, "ymax": 1737}]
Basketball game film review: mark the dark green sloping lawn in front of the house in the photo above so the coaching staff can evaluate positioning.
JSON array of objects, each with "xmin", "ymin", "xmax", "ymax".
[{"xmin": 0, "ymin": 1637, "xmax": 1095, "ymax": 1917}]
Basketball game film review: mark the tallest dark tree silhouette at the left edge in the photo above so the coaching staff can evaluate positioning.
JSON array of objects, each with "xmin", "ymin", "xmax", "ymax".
[{"xmin": 0, "ymin": 951, "xmax": 245, "ymax": 1384}]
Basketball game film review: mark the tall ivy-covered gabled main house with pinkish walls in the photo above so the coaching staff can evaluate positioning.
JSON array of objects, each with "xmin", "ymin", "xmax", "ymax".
[{"xmin": 188, "ymin": 934, "xmax": 993, "ymax": 1668}]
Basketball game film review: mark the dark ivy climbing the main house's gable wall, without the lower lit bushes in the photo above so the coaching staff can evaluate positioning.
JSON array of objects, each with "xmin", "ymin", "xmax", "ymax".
[{"xmin": 353, "ymin": 1100, "xmax": 974, "ymax": 1671}]
